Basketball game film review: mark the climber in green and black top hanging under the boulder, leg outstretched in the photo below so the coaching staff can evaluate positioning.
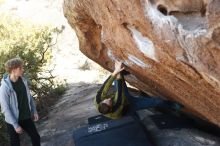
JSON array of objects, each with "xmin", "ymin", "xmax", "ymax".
[{"xmin": 94, "ymin": 61, "xmax": 182, "ymax": 119}]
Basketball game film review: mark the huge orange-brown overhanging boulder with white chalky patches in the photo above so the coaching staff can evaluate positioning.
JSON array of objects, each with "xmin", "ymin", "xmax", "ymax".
[{"xmin": 64, "ymin": 0, "xmax": 220, "ymax": 127}]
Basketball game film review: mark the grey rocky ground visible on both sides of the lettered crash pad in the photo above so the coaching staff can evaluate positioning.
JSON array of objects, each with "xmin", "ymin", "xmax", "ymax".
[{"xmin": 33, "ymin": 82, "xmax": 220, "ymax": 146}]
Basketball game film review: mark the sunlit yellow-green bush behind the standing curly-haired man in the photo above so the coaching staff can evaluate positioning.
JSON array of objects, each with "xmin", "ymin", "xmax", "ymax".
[{"xmin": 0, "ymin": 16, "xmax": 66, "ymax": 144}]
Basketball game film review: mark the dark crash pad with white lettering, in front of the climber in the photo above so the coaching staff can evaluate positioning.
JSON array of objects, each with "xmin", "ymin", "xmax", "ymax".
[{"xmin": 73, "ymin": 116, "xmax": 152, "ymax": 146}]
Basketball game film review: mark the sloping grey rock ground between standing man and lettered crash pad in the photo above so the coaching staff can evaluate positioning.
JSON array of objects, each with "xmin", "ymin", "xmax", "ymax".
[{"xmin": 38, "ymin": 82, "xmax": 100, "ymax": 146}]
